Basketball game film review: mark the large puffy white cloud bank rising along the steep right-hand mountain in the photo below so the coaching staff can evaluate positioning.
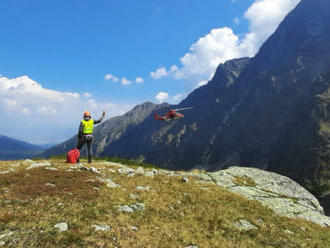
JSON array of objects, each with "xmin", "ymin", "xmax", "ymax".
[{"xmin": 150, "ymin": 0, "xmax": 300, "ymax": 83}]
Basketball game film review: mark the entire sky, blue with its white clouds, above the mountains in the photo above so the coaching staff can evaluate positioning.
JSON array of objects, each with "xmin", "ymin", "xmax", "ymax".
[{"xmin": 0, "ymin": 0, "xmax": 299, "ymax": 143}]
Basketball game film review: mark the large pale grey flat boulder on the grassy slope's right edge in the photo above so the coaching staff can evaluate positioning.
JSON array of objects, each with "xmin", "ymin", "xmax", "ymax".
[{"xmin": 201, "ymin": 167, "xmax": 330, "ymax": 226}]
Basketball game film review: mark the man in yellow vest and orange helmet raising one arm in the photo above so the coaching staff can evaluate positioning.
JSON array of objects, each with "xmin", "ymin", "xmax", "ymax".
[{"xmin": 77, "ymin": 111, "xmax": 105, "ymax": 163}]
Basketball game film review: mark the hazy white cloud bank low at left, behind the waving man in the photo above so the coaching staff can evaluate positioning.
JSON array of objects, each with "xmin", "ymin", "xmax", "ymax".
[{"xmin": 0, "ymin": 76, "xmax": 132, "ymax": 143}]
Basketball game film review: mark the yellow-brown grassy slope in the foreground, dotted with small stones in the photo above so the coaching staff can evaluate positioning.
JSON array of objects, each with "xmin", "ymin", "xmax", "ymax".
[{"xmin": 0, "ymin": 160, "xmax": 330, "ymax": 248}]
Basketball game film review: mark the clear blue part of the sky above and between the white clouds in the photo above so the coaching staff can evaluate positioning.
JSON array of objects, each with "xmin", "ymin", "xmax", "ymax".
[{"xmin": 0, "ymin": 0, "xmax": 251, "ymax": 104}]
